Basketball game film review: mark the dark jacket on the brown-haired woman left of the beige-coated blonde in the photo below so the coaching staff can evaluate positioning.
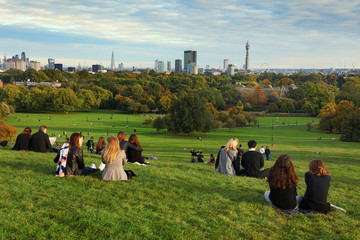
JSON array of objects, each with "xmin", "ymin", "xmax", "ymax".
[{"xmin": 65, "ymin": 146, "xmax": 85, "ymax": 175}]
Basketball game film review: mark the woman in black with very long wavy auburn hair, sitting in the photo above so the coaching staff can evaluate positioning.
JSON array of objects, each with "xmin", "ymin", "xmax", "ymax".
[{"xmin": 264, "ymin": 155, "xmax": 302, "ymax": 215}]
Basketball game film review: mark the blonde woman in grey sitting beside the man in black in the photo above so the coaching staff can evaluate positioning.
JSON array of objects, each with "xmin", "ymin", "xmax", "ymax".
[{"xmin": 216, "ymin": 138, "xmax": 239, "ymax": 175}]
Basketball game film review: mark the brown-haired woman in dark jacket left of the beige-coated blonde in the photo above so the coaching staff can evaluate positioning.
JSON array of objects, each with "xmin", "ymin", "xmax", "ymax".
[{"xmin": 65, "ymin": 133, "xmax": 100, "ymax": 176}]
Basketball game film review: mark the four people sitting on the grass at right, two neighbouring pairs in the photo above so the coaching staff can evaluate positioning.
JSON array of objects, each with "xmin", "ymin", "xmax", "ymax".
[{"xmin": 215, "ymin": 138, "xmax": 331, "ymax": 215}]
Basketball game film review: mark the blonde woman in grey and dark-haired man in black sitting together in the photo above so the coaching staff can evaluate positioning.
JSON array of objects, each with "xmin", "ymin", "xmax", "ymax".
[{"xmin": 215, "ymin": 138, "xmax": 269, "ymax": 178}]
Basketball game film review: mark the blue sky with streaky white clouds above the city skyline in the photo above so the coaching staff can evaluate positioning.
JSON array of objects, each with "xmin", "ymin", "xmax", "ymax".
[{"xmin": 0, "ymin": 0, "xmax": 360, "ymax": 69}]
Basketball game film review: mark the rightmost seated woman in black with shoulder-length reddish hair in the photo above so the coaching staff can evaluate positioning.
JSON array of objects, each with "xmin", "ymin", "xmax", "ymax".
[{"xmin": 300, "ymin": 159, "xmax": 331, "ymax": 214}]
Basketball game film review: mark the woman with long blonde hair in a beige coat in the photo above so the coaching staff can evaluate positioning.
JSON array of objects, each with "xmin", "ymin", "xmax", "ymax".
[{"xmin": 101, "ymin": 136, "xmax": 128, "ymax": 181}]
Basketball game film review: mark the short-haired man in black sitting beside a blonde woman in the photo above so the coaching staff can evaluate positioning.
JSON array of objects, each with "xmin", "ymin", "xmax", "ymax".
[{"xmin": 241, "ymin": 140, "xmax": 269, "ymax": 178}]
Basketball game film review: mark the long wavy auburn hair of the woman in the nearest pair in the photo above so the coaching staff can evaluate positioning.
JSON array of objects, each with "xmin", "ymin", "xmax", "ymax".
[{"xmin": 267, "ymin": 154, "xmax": 299, "ymax": 189}]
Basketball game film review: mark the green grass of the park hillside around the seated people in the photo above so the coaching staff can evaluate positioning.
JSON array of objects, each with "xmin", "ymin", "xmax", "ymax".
[{"xmin": 0, "ymin": 112, "xmax": 360, "ymax": 239}]
